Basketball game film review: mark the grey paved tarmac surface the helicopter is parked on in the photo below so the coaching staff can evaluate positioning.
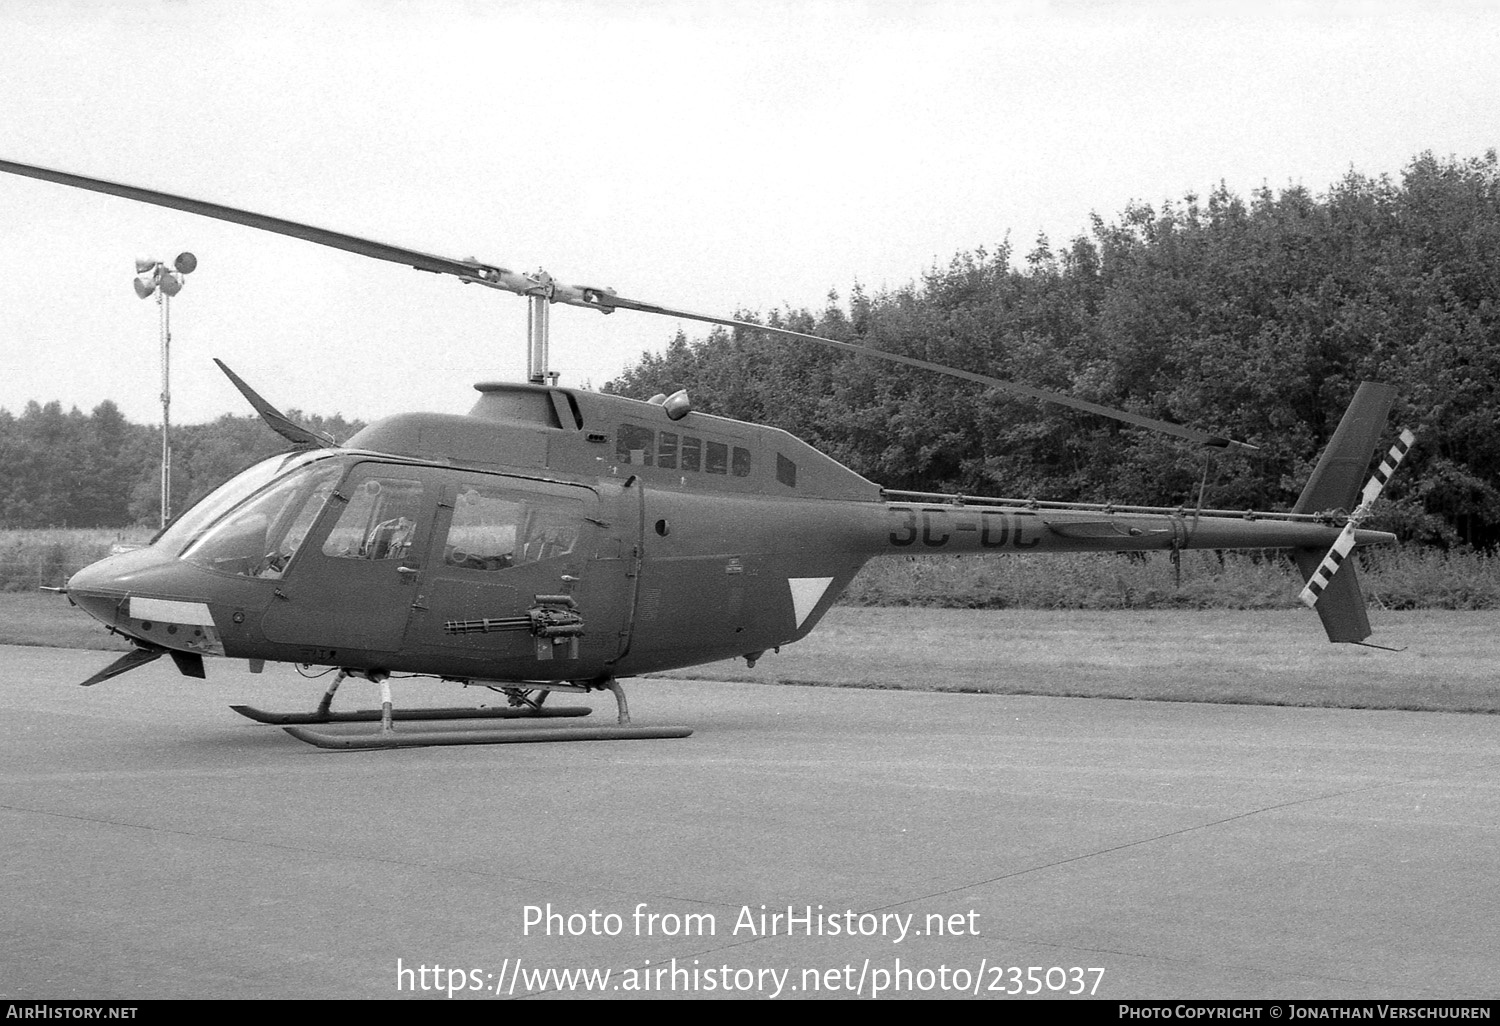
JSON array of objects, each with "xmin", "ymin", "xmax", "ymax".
[{"xmin": 0, "ymin": 648, "xmax": 1500, "ymax": 1001}]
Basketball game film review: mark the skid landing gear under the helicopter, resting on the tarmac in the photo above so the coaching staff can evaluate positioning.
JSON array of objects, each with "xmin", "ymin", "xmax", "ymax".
[{"xmin": 238, "ymin": 671, "xmax": 693, "ymax": 750}]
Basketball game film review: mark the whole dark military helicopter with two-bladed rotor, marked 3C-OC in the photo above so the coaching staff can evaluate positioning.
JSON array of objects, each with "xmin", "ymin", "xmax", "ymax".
[{"xmin": 0, "ymin": 161, "xmax": 1413, "ymax": 749}]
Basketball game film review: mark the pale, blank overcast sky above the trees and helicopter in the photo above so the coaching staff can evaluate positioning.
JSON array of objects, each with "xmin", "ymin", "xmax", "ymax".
[{"xmin": 0, "ymin": 0, "xmax": 1500, "ymax": 423}]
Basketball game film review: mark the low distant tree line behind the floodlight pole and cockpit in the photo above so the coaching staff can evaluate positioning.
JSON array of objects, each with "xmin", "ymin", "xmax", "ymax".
[{"xmin": 0, "ymin": 401, "xmax": 363, "ymax": 528}]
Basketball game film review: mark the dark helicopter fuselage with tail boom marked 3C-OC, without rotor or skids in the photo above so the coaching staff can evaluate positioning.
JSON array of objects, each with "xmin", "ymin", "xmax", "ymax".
[{"xmin": 69, "ymin": 386, "xmax": 1389, "ymax": 683}]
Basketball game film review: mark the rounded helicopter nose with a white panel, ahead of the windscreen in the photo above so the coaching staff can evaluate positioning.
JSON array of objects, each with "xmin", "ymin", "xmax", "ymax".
[{"xmin": 68, "ymin": 548, "xmax": 224, "ymax": 656}]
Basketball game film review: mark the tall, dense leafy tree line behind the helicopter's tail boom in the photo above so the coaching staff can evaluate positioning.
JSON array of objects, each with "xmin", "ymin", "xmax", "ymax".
[{"xmin": 605, "ymin": 150, "xmax": 1500, "ymax": 546}]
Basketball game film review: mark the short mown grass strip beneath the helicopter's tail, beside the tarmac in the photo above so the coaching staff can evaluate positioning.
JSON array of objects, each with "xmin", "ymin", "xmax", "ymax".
[{"xmin": 654, "ymin": 608, "xmax": 1500, "ymax": 713}]
